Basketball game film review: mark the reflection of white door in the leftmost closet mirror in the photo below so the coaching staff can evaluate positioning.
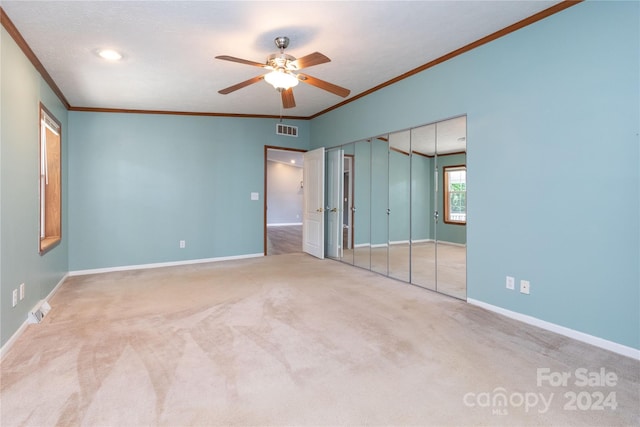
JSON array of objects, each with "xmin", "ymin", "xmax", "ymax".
[{"xmin": 327, "ymin": 148, "xmax": 344, "ymax": 258}]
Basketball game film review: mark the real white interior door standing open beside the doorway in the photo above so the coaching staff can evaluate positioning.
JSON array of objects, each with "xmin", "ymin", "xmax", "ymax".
[{"xmin": 302, "ymin": 148, "xmax": 324, "ymax": 259}]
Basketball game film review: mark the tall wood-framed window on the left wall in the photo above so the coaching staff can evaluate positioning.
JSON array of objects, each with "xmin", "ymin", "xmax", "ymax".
[{"xmin": 38, "ymin": 103, "xmax": 62, "ymax": 255}]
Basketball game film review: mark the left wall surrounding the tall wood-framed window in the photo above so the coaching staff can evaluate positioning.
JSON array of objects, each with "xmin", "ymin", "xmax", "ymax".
[{"xmin": 0, "ymin": 28, "xmax": 69, "ymax": 345}]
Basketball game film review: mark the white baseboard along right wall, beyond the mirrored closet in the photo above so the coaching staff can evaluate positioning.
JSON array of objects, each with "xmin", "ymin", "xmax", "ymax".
[{"xmin": 467, "ymin": 298, "xmax": 640, "ymax": 360}]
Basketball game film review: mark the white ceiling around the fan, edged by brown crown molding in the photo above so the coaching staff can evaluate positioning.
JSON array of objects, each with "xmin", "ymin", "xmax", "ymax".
[{"xmin": 2, "ymin": 0, "xmax": 559, "ymax": 117}]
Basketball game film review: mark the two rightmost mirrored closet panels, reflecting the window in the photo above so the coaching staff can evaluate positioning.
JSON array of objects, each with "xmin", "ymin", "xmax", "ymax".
[{"xmin": 411, "ymin": 116, "xmax": 466, "ymax": 299}]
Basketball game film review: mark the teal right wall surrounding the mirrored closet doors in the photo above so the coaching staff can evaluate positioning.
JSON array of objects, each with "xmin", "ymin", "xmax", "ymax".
[{"xmin": 311, "ymin": 1, "xmax": 640, "ymax": 348}]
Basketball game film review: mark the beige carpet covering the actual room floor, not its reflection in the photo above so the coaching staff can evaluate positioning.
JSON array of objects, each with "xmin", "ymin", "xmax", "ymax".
[{"xmin": 0, "ymin": 254, "xmax": 640, "ymax": 427}]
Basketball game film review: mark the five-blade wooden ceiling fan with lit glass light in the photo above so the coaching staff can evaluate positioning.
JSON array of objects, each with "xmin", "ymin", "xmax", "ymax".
[{"xmin": 216, "ymin": 37, "xmax": 351, "ymax": 108}]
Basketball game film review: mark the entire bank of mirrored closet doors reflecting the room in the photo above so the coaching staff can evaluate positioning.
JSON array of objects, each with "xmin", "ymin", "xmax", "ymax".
[{"xmin": 326, "ymin": 116, "xmax": 467, "ymax": 299}]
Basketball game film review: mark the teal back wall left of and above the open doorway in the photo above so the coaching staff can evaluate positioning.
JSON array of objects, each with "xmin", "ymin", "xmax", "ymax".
[{"xmin": 69, "ymin": 111, "xmax": 309, "ymax": 271}]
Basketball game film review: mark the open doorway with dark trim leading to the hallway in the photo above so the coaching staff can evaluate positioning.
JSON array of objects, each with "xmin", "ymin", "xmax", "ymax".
[{"xmin": 264, "ymin": 146, "xmax": 305, "ymax": 255}]
